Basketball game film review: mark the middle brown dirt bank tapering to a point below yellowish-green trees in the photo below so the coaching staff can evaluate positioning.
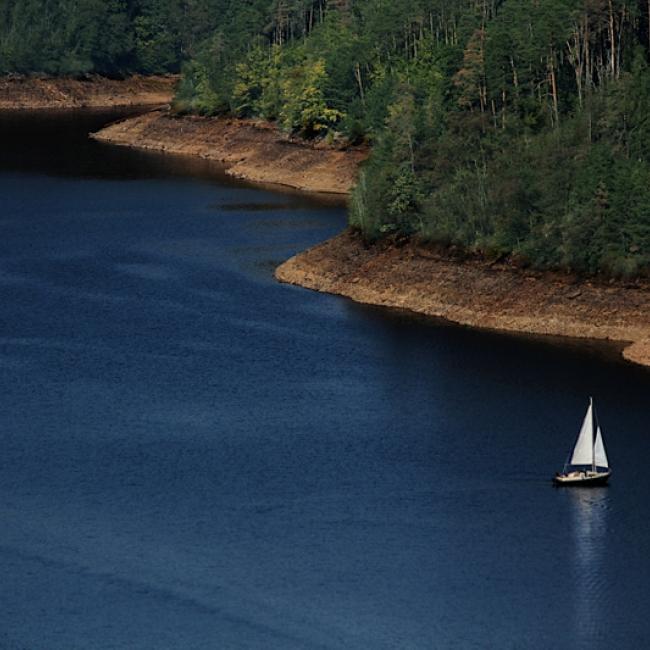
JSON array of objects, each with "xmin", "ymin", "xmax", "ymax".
[{"xmin": 93, "ymin": 111, "xmax": 368, "ymax": 194}]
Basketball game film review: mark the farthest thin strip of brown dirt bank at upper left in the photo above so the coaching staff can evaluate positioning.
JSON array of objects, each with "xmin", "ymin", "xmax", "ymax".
[{"xmin": 0, "ymin": 76, "xmax": 178, "ymax": 110}]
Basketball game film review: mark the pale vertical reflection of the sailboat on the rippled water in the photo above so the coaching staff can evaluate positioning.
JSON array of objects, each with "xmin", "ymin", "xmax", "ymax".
[{"xmin": 567, "ymin": 487, "xmax": 609, "ymax": 642}]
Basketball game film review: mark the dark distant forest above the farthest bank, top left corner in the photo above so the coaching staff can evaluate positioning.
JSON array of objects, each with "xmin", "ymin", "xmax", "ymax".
[{"xmin": 0, "ymin": 0, "xmax": 225, "ymax": 75}]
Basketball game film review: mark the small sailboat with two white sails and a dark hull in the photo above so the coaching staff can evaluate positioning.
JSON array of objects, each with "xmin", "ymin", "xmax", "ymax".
[{"xmin": 553, "ymin": 397, "xmax": 612, "ymax": 486}]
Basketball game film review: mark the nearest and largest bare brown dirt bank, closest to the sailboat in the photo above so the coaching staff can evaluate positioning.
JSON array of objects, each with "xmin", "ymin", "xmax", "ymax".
[{"xmin": 276, "ymin": 232, "xmax": 650, "ymax": 365}]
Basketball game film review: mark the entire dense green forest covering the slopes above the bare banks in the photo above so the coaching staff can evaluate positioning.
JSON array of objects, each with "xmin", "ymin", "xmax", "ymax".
[{"xmin": 0, "ymin": 0, "xmax": 650, "ymax": 278}]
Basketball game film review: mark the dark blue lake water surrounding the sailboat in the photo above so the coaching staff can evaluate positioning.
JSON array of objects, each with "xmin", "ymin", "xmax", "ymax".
[{"xmin": 0, "ymin": 113, "xmax": 650, "ymax": 650}]
